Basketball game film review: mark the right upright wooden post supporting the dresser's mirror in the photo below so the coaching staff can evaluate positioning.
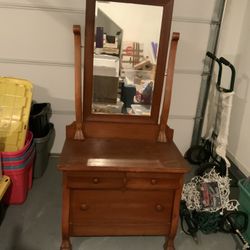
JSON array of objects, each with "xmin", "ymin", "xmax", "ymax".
[{"xmin": 158, "ymin": 32, "xmax": 180, "ymax": 142}]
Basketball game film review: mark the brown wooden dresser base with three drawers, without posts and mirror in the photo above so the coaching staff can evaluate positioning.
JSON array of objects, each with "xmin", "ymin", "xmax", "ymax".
[{"xmin": 59, "ymin": 139, "xmax": 188, "ymax": 250}]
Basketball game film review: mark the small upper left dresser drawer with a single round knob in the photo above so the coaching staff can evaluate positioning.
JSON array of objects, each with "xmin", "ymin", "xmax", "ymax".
[{"xmin": 67, "ymin": 172, "xmax": 126, "ymax": 189}]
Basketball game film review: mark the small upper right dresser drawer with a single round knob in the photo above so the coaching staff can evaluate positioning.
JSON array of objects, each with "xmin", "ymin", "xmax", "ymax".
[{"xmin": 126, "ymin": 173, "xmax": 181, "ymax": 190}]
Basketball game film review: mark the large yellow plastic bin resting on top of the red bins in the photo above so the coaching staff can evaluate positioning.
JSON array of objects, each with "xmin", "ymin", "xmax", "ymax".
[{"xmin": 0, "ymin": 77, "xmax": 32, "ymax": 152}]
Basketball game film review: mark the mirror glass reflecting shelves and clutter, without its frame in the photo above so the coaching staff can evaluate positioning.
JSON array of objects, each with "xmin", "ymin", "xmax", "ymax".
[{"xmin": 92, "ymin": 1, "xmax": 163, "ymax": 116}]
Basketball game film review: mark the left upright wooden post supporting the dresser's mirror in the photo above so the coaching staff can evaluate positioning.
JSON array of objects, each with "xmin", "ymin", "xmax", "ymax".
[{"xmin": 73, "ymin": 25, "xmax": 84, "ymax": 140}]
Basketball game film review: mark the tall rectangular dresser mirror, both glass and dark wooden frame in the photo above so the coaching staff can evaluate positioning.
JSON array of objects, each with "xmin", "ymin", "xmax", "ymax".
[{"xmin": 83, "ymin": 0, "xmax": 172, "ymax": 124}]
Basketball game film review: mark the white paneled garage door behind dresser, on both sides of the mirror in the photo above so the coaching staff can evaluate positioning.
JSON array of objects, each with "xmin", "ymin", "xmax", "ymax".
[{"xmin": 0, "ymin": 0, "xmax": 215, "ymax": 153}]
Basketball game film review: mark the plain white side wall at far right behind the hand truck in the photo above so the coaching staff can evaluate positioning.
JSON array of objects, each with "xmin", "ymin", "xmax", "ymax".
[{"xmin": 218, "ymin": 0, "xmax": 250, "ymax": 176}]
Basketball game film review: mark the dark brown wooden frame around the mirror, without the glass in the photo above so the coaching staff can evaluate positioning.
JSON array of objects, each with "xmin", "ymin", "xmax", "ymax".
[{"xmin": 83, "ymin": 0, "xmax": 174, "ymax": 125}]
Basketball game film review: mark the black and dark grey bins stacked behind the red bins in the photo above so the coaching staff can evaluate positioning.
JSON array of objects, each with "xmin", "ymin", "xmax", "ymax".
[{"xmin": 29, "ymin": 103, "xmax": 55, "ymax": 178}]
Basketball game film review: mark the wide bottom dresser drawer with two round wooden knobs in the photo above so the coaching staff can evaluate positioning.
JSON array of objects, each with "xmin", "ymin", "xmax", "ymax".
[{"xmin": 70, "ymin": 189, "xmax": 174, "ymax": 227}]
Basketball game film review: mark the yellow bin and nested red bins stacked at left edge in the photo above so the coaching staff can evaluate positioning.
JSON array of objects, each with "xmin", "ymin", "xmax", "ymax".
[{"xmin": 0, "ymin": 77, "xmax": 35, "ymax": 204}]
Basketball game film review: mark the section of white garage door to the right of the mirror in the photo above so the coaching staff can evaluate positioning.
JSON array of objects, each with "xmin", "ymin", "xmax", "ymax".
[{"xmin": 169, "ymin": 0, "xmax": 215, "ymax": 153}]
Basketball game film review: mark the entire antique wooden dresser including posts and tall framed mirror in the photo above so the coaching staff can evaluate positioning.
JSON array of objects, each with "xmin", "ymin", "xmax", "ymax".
[{"xmin": 58, "ymin": 0, "xmax": 189, "ymax": 250}]
